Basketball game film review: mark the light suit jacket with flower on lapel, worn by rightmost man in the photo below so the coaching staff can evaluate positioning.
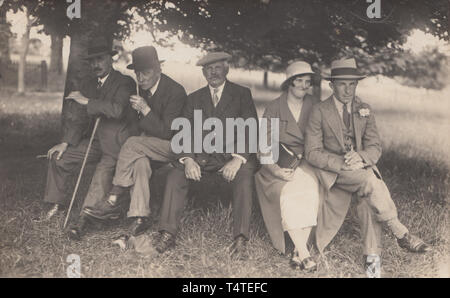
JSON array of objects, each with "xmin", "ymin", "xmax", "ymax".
[{"xmin": 306, "ymin": 96, "xmax": 381, "ymax": 189}]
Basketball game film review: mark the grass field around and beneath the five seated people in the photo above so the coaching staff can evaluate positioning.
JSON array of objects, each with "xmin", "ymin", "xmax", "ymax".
[{"xmin": 0, "ymin": 71, "xmax": 450, "ymax": 277}]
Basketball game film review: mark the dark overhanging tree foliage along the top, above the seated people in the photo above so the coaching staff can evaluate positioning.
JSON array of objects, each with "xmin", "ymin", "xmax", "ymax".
[{"xmin": 139, "ymin": 0, "xmax": 449, "ymax": 69}]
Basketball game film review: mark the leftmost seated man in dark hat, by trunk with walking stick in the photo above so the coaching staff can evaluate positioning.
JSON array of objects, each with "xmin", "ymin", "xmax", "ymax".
[{"xmin": 44, "ymin": 38, "xmax": 138, "ymax": 239}]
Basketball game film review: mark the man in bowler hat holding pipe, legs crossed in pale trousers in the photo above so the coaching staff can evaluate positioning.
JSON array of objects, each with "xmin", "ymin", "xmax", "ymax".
[{"xmin": 86, "ymin": 46, "xmax": 187, "ymax": 236}]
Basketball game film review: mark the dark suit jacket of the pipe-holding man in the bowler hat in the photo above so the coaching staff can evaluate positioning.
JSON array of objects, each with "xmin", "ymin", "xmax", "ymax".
[{"xmin": 139, "ymin": 74, "xmax": 187, "ymax": 140}]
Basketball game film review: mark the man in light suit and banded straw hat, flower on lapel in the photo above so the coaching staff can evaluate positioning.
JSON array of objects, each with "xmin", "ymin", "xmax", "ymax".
[{"xmin": 306, "ymin": 59, "xmax": 430, "ymax": 269}]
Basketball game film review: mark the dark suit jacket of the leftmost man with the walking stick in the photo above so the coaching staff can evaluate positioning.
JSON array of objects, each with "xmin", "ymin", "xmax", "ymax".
[{"xmin": 62, "ymin": 70, "xmax": 138, "ymax": 157}]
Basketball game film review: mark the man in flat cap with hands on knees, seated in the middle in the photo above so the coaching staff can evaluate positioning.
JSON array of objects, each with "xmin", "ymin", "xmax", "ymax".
[{"xmin": 155, "ymin": 52, "xmax": 257, "ymax": 256}]
